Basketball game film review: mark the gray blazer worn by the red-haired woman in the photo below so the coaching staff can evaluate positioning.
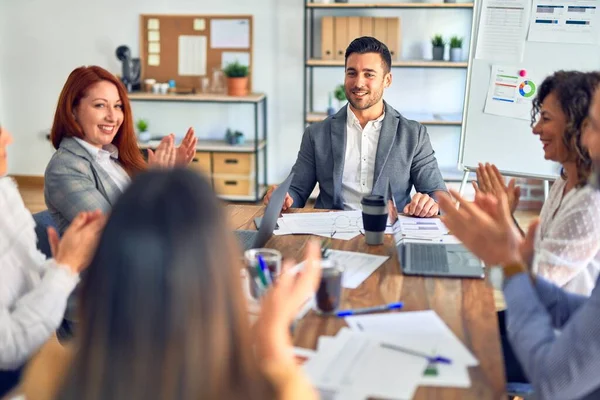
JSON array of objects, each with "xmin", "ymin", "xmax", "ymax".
[{"xmin": 44, "ymin": 138, "xmax": 121, "ymax": 234}]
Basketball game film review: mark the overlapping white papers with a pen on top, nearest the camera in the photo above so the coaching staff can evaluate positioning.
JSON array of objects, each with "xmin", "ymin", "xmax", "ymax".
[{"xmin": 303, "ymin": 311, "xmax": 478, "ymax": 400}]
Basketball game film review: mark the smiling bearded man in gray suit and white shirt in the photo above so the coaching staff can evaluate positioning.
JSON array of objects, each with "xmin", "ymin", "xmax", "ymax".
[{"xmin": 265, "ymin": 37, "xmax": 446, "ymax": 217}]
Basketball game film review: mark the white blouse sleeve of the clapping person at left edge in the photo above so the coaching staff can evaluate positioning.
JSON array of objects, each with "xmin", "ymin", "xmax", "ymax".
[{"xmin": 0, "ymin": 177, "xmax": 79, "ymax": 370}]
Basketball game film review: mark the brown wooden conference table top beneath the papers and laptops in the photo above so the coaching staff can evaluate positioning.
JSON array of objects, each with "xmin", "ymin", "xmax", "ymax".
[{"xmin": 227, "ymin": 205, "xmax": 506, "ymax": 400}]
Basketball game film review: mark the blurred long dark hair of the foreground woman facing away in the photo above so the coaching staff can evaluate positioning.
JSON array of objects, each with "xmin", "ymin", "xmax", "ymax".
[{"xmin": 57, "ymin": 170, "xmax": 271, "ymax": 399}]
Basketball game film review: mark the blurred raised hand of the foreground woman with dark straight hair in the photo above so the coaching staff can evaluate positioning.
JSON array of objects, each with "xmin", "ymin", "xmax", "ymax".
[{"xmin": 254, "ymin": 241, "xmax": 321, "ymax": 365}]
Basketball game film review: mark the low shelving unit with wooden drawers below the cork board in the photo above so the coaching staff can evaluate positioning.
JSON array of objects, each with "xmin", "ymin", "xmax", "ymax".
[{"xmin": 134, "ymin": 92, "xmax": 268, "ymax": 202}]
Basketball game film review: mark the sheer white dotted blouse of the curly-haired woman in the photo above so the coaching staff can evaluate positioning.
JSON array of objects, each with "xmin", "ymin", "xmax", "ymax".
[{"xmin": 532, "ymin": 178, "xmax": 600, "ymax": 296}]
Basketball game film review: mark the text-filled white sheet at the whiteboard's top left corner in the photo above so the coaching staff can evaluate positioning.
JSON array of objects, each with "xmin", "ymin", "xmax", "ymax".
[{"xmin": 475, "ymin": 0, "xmax": 529, "ymax": 62}]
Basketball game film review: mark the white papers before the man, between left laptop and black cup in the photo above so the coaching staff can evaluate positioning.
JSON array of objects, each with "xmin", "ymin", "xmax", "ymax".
[{"xmin": 273, "ymin": 210, "xmax": 394, "ymax": 240}]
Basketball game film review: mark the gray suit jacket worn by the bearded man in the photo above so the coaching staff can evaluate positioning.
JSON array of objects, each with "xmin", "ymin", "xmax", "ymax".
[{"xmin": 289, "ymin": 103, "xmax": 446, "ymax": 210}]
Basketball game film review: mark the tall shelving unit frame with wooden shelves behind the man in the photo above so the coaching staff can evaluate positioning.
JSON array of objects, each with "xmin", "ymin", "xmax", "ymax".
[{"xmin": 303, "ymin": 0, "xmax": 473, "ymax": 126}]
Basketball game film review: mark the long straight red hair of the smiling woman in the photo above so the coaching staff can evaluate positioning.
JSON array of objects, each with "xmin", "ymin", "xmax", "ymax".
[{"xmin": 50, "ymin": 65, "xmax": 146, "ymax": 175}]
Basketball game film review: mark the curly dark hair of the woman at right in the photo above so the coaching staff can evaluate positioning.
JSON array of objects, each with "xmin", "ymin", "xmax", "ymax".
[{"xmin": 531, "ymin": 71, "xmax": 600, "ymax": 187}]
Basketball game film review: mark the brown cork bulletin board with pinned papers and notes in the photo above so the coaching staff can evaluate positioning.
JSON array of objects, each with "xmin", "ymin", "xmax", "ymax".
[{"xmin": 140, "ymin": 14, "xmax": 253, "ymax": 92}]
